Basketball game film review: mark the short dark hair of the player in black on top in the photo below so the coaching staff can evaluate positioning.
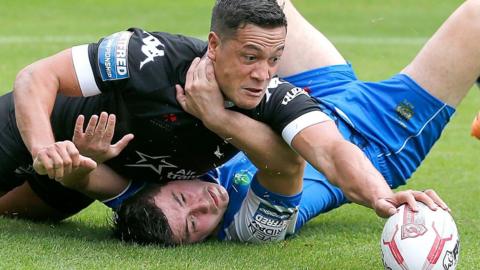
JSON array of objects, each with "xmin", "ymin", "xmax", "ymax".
[{"xmin": 210, "ymin": 0, "xmax": 287, "ymax": 39}]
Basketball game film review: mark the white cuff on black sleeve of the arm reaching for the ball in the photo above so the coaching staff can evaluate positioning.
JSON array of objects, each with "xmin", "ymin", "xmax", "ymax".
[{"xmin": 282, "ymin": 111, "xmax": 333, "ymax": 146}]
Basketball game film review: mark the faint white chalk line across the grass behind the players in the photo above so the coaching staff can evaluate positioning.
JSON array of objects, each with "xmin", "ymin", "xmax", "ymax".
[{"xmin": 0, "ymin": 35, "xmax": 427, "ymax": 45}]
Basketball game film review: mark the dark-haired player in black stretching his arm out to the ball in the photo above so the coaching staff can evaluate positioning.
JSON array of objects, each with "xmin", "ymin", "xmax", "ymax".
[{"xmin": 0, "ymin": 0, "xmax": 415, "ymax": 219}]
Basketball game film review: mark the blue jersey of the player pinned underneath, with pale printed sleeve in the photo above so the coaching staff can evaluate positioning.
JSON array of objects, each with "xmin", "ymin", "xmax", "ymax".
[{"xmin": 204, "ymin": 153, "xmax": 346, "ymax": 243}]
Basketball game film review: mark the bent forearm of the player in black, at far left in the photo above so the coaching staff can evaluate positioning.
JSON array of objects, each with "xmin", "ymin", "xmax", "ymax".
[{"xmin": 13, "ymin": 66, "xmax": 58, "ymax": 156}]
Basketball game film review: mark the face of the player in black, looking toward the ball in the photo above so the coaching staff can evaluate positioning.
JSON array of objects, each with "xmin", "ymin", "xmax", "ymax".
[{"xmin": 208, "ymin": 24, "xmax": 286, "ymax": 109}]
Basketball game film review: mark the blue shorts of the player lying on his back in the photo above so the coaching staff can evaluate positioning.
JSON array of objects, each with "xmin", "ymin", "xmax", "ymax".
[{"xmin": 285, "ymin": 65, "xmax": 455, "ymax": 188}]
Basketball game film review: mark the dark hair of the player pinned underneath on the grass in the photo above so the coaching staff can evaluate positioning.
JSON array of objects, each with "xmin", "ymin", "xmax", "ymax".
[{"xmin": 113, "ymin": 185, "xmax": 178, "ymax": 246}]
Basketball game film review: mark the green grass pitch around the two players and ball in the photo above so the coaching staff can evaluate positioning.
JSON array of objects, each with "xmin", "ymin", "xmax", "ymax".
[{"xmin": 0, "ymin": 0, "xmax": 480, "ymax": 269}]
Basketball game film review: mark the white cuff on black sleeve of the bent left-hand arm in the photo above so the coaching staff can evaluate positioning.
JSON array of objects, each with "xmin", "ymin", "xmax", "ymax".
[{"xmin": 72, "ymin": 44, "xmax": 101, "ymax": 97}]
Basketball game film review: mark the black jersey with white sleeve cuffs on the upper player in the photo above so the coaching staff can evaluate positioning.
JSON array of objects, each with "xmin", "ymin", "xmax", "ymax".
[{"xmin": 65, "ymin": 28, "xmax": 323, "ymax": 181}]
